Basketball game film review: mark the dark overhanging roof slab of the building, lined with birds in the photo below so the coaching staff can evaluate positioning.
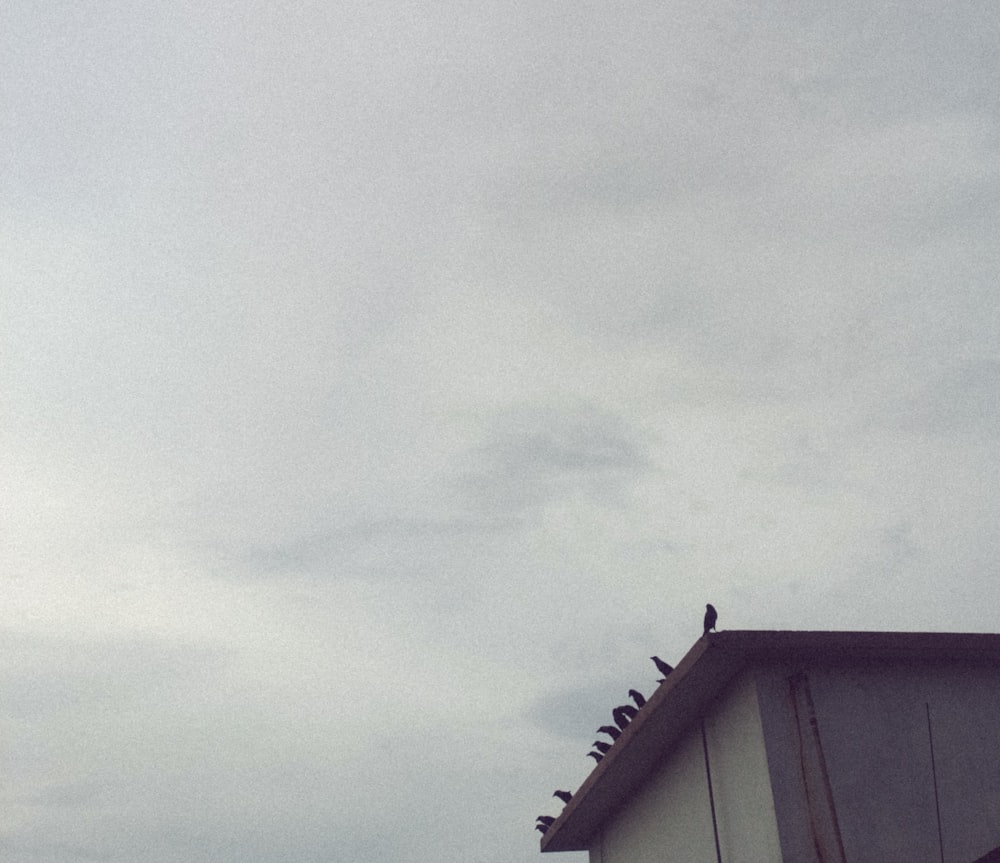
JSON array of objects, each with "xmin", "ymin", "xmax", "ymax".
[{"xmin": 541, "ymin": 630, "xmax": 1000, "ymax": 851}]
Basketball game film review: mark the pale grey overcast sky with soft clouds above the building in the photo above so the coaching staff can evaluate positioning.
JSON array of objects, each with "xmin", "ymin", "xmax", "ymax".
[{"xmin": 0, "ymin": 0, "xmax": 1000, "ymax": 863}]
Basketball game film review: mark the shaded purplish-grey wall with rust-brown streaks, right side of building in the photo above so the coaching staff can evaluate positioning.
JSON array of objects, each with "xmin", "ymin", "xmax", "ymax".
[{"xmin": 759, "ymin": 663, "xmax": 1000, "ymax": 863}]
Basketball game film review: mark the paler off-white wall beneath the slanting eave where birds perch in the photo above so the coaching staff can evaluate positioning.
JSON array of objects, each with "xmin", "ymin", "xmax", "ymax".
[{"xmin": 590, "ymin": 675, "xmax": 781, "ymax": 863}]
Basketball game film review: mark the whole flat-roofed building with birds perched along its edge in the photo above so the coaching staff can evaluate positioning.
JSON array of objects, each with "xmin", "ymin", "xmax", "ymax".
[{"xmin": 541, "ymin": 631, "xmax": 1000, "ymax": 863}]
